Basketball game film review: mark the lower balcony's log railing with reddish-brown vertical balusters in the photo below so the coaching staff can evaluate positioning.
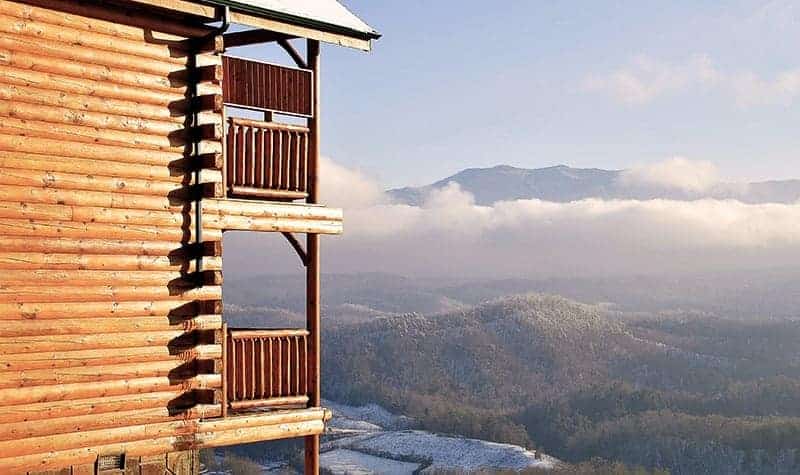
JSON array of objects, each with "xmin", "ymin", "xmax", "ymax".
[{"xmin": 225, "ymin": 329, "xmax": 309, "ymax": 411}]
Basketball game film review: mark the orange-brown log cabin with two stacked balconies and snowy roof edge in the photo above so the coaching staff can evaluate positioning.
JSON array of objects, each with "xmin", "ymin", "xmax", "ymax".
[{"xmin": 0, "ymin": 0, "xmax": 379, "ymax": 475}]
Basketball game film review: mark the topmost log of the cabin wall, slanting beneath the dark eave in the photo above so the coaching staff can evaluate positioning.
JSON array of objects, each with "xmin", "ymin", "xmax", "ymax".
[{"xmin": 9, "ymin": 0, "xmax": 213, "ymax": 41}]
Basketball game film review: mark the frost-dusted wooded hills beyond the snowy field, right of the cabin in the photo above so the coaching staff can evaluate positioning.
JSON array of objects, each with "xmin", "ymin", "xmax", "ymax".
[{"xmin": 324, "ymin": 295, "xmax": 800, "ymax": 474}]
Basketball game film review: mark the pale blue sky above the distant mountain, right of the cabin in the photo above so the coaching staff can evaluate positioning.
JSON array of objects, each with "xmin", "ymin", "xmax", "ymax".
[{"xmin": 241, "ymin": 0, "xmax": 800, "ymax": 186}]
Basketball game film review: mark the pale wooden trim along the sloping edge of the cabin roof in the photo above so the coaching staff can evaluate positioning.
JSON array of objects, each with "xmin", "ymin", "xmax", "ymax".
[{"xmin": 124, "ymin": 0, "xmax": 381, "ymax": 51}]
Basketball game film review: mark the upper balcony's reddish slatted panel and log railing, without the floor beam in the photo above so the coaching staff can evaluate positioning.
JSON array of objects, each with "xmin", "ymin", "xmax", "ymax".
[{"xmin": 222, "ymin": 56, "xmax": 317, "ymax": 201}]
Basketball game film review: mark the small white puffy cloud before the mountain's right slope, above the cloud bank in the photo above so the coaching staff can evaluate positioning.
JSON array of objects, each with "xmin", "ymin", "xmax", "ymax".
[{"xmin": 620, "ymin": 157, "xmax": 720, "ymax": 194}]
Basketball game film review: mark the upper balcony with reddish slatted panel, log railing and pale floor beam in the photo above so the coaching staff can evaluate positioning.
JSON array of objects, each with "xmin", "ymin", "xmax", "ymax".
[{"xmin": 203, "ymin": 56, "xmax": 342, "ymax": 234}]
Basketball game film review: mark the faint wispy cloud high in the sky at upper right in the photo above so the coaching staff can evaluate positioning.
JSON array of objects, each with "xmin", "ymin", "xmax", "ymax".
[{"xmin": 583, "ymin": 55, "xmax": 800, "ymax": 107}]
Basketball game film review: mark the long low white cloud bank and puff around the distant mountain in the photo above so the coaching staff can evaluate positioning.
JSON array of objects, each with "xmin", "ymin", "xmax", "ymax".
[{"xmin": 225, "ymin": 159, "xmax": 800, "ymax": 277}]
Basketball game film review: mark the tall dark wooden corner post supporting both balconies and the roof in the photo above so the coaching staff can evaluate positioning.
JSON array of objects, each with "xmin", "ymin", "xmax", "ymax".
[{"xmin": 305, "ymin": 40, "xmax": 321, "ymax": 474}]
